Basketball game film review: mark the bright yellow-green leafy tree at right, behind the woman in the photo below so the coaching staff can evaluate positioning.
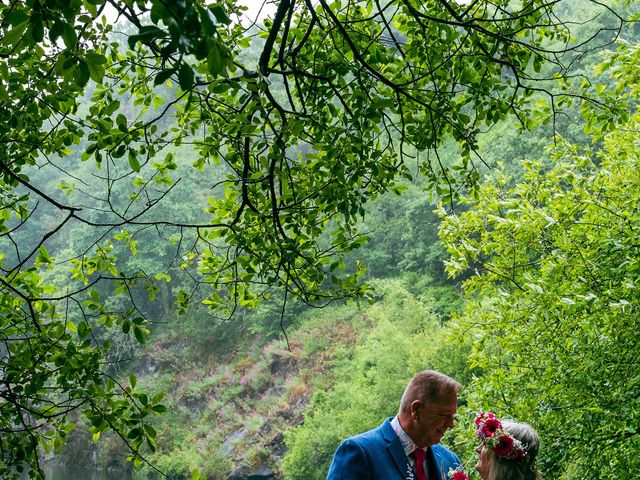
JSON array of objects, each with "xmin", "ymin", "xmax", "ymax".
[{"xmin": 441, "ymin": 40, "xmax": 640, "ymax": 479}]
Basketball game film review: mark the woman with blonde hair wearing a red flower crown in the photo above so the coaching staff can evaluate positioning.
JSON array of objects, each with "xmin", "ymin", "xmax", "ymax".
[{"xmin": 475, "ymin": 413, "xmax": 541, "ymax": 480}]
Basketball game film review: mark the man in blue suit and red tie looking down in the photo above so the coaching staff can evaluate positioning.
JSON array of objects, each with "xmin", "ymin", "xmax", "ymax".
[{"xmin": 327, "ymin": 370, "xmax": 462, "ymax": 480}]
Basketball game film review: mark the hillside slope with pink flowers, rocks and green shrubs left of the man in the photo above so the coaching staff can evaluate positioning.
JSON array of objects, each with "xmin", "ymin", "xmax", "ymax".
[{"xmin": 52, "ymin": 277, "xmax": 468, "ymax": 480}]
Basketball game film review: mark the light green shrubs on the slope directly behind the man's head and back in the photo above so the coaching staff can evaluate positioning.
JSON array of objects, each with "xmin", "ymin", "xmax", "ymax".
[{"xmin": 282, "ymin": 280, "xmax": 468, "ymax": 480}]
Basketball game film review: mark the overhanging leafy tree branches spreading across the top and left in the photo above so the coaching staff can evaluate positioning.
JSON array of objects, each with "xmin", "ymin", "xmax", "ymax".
[{"xmin": 0, "ymin": 0, "xmax": 625, "ymax": 475}]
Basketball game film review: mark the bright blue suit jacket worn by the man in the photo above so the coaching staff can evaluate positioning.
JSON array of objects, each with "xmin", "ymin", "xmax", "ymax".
[{"xmin": 327, "ymin": 418, "xmax": 460, "ymax": 480}]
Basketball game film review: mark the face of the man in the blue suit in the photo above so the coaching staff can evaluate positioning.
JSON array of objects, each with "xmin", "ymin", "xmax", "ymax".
[{"xmin": 414, "ymin": 393, "xmax": 458, "ymax": 447}]
